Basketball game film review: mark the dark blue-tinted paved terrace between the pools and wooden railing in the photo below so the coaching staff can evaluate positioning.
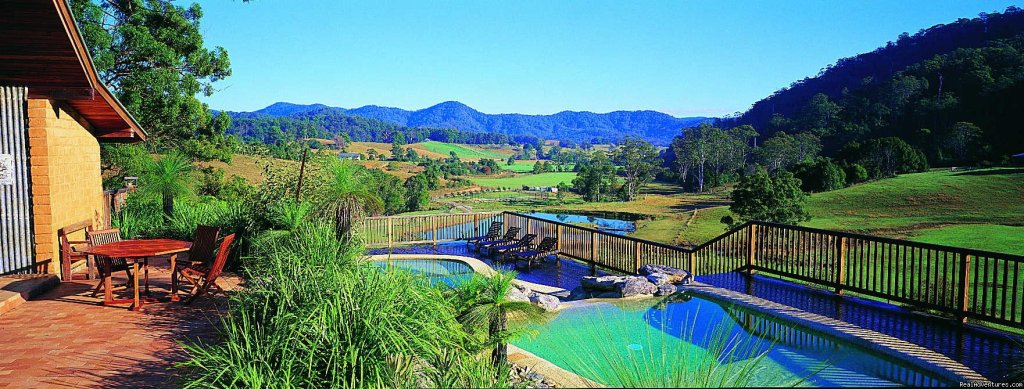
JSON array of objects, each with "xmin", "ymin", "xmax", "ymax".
[{"xmin": 370, "ymin": 243, "xmax": 1024, "ymax": 382}]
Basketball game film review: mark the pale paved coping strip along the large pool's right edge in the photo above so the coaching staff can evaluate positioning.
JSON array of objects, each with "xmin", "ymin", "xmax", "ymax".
[{"xmin": 679, "ymin": 282, "xmax": 991, "ymax": 384}]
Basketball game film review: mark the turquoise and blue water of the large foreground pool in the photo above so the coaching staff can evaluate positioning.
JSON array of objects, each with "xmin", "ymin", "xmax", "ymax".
[{"xmin": 513, "ymin": 294, "xmax": 955, "ymax": 387}]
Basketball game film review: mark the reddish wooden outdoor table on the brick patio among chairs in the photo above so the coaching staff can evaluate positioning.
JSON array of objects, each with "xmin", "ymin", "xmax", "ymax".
[{"xmin": 82, "ymin": 240, "xmax": 191, "ymax": 310}]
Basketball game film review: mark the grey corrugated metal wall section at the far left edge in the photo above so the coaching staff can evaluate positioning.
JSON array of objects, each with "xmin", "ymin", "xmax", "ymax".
[{"xmin": 0, "ymin": 86, "xmax": 35, "ymax": 274}]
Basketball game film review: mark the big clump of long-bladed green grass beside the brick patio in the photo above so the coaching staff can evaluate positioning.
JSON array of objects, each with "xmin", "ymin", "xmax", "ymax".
[{"xmin": 182, "ymin": 221, "xmax": 516, "ymax": 388}]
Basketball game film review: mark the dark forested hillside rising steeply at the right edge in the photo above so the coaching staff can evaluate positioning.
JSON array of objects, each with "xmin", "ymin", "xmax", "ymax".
[{"xmin": 719, "ymin": 7, "xmax": 1024, "ymax": 166}]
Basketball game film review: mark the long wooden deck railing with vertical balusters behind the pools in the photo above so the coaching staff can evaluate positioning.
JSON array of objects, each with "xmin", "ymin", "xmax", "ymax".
[{"xmin": 361, "ymin": 212, "xmax": 1024, "ymax": 327}]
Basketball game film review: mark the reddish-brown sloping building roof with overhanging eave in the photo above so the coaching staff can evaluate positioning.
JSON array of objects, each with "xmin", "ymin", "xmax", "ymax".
[{"xmin": 0, "ymin": 0, "xmax": 146, "ymax": 142}]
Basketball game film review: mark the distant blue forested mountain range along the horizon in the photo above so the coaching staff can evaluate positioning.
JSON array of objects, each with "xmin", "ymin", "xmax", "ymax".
[{"xmin": 222, "ymin": 101, "xmax": 709, "ymax": 144}]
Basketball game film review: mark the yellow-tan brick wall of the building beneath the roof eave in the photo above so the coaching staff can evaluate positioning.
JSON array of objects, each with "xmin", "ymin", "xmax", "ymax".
[{"xmin": 29, "ymin": 99, "xmax": 103, "ymax": 273}]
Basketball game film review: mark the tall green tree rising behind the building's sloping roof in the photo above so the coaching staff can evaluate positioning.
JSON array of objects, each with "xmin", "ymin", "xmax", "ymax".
[{"xmin": 70, "ymin": 0, "xmax": 231, "ymax": 151}]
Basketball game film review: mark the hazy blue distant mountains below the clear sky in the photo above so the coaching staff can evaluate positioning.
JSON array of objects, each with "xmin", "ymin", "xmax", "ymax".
[{"xmin": 220, "ymin": 101, "xmax": 711, "ymax": 145}]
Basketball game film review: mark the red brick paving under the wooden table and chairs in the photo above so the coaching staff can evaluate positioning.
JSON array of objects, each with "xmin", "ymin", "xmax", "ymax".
[{"xmin": 0, "ymin": 256, "xmax": 238, "ymax": 388}]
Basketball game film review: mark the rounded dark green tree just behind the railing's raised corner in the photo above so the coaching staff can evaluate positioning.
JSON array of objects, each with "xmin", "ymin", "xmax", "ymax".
[{"xmin": 723, "ymin": 167, "xmax": 810, "ymax": 225}]
